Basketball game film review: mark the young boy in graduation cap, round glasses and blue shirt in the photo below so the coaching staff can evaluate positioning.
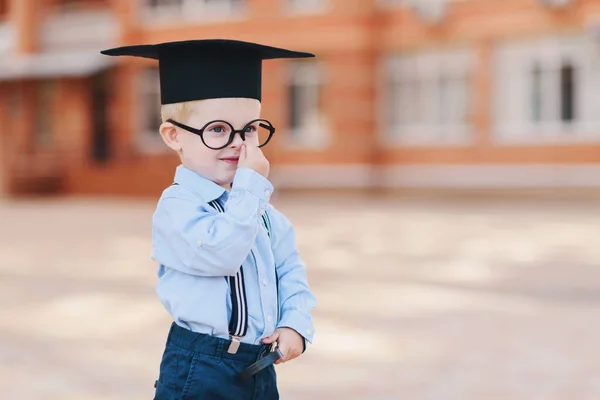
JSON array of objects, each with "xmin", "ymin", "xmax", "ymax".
[{"xmin": 102, "ymin": 40, "xmax": 315, "ymax": 400}]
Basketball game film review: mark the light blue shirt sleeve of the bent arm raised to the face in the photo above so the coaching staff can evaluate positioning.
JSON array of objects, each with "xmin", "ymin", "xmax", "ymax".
[{"xmin": 152, "ymin": 168, "xmax": 273, "ymax": 276}]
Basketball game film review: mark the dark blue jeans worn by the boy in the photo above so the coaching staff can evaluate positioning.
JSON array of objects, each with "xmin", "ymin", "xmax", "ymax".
[{"xmin": 154, "ymin": 323, "xmax": 279, "ymax": 400}]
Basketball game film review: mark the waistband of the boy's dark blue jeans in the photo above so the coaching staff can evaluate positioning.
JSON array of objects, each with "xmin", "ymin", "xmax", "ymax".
[{"xmin": 167, "ymin": 322, "xmax": 269, "ymax": 362}]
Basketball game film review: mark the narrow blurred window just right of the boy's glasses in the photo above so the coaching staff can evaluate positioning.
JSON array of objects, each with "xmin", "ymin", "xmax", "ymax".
[{"xmin": 288, "ymin": 61, "xmax": 328, "ymax": 147}]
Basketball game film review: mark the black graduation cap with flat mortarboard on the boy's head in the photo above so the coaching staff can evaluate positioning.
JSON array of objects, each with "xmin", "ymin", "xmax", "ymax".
[{"xmin": 101, "ymin": 39, "xmax": 314, "ymax": 104}]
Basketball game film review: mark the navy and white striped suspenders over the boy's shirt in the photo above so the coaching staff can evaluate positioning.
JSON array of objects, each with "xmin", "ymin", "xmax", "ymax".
[{"xmin": 209, "ymin": 200, "xmax": 279, "ymax": 354}]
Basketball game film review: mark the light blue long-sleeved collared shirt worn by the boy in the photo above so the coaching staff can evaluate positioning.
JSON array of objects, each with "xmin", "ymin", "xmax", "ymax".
[{"xmin": 152, "ymin": 165, "xmax": 316, "ymax": 344}]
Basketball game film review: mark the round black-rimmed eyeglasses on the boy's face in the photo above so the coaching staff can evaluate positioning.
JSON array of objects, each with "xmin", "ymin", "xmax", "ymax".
[{"xmin": 166, "ymin": 119, "xmax": 275, "ymax": 150}]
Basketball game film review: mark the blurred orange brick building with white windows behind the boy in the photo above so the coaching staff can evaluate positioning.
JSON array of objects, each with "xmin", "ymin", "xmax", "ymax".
[{"xmin": 0, "ymin": 0, "xmax": 600, "ymax": 195}]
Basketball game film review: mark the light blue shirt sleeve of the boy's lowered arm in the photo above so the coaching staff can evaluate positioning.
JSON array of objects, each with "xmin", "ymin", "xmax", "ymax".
[{"xmin": 269, "ymin": 207, "xmax": 316, "ymax": 343}]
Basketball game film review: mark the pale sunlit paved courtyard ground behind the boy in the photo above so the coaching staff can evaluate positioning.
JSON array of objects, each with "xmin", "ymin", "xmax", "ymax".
[{"xmin": 0, "ymin": 195, "xmax": 600, "ymax": 400}]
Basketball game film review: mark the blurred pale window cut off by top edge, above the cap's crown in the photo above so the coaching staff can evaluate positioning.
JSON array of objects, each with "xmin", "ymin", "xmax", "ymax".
[{"xmin": 145, "ymin": 0, "xmax": 245, "ymax": 23}]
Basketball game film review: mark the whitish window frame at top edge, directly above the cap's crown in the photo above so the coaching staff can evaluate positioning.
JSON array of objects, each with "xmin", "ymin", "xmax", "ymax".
[{"xmin": 138, "ymin": 0, "xmax": 244, "ymax": 27}]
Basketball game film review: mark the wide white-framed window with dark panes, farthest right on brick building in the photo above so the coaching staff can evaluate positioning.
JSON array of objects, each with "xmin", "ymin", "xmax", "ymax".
[{"xmin": 493, "ymin": 35, "xmax": 600, "ymax": 143}]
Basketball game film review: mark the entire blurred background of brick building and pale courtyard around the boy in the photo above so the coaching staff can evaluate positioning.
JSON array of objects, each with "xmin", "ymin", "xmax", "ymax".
[{"xmin": 0, "ymin": 0, "xmax": 600, "ymax": 400}]
